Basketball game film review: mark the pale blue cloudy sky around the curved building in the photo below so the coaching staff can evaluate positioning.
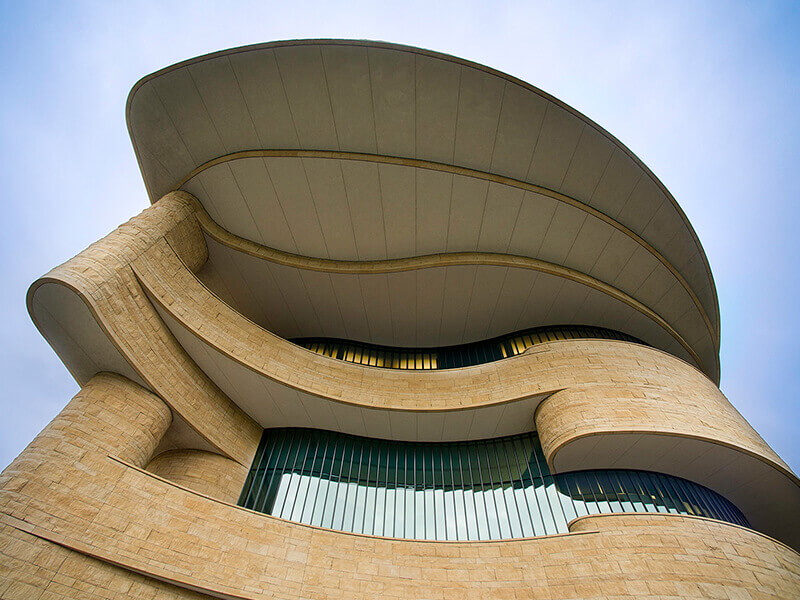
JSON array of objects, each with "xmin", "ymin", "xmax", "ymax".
[{"xmin": 0, "ymin": 0, "xmax": 800, "ymax": 473}]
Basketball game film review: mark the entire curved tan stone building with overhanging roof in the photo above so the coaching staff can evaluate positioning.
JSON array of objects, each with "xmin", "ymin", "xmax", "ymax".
[{"xmin": 0, "ymin": 40, "xmax": 800, "ymax": 599}]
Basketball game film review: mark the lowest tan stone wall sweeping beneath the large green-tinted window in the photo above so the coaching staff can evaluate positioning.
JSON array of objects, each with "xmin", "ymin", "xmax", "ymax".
[{"xmin": 0, "ymin": 376, "xmax": 800, "ymax": 599}]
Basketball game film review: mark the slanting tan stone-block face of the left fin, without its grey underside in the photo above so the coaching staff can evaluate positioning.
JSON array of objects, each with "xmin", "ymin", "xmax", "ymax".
[{"xmin": 31, "ymin": 193, "xmax": 261, "ymax": 465}]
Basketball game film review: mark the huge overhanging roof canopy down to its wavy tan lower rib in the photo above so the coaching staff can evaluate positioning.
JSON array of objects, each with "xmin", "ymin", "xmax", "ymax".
[{"xmin": 128, "ymin": 40, "xmax": 719, "ymax": 381}]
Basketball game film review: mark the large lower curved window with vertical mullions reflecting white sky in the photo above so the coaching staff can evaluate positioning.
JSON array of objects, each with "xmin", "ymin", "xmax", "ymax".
[{"xmin": 239, "ymin": 429, "xmax": 747, "ymax": 540}]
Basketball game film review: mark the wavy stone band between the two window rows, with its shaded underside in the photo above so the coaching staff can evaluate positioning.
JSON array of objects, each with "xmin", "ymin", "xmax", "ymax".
[{"xmin": 128, "ymin": 223, "xmax": 800, "ymax": 544}]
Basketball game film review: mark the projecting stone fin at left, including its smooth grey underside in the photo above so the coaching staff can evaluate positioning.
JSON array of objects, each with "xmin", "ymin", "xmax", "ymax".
[{"xmin": 28, "ymin": 193, "xmax": 261, "ymax": 465}]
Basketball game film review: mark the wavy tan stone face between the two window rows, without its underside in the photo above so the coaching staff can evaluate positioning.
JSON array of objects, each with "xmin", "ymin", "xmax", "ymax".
[{"xmin": 133, "ymin": 231, "xmax": 789, "ymax": 478}]
